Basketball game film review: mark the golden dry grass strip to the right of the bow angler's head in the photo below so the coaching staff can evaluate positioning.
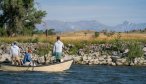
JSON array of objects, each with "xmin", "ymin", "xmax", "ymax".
[{"xmin": 62, "ymin": 33, "xmax": 146, "ymax": 40}]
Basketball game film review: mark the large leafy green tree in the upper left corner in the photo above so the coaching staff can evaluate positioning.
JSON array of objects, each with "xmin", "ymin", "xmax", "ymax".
[{"xmin": 0, "ymin": 0, "xmax": 46, "ymax": 36}]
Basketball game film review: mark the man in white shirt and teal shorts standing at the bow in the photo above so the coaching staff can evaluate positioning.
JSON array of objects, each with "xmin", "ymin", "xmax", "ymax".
[{"xmin": 53, "ymin": 36, "xmax": 64, "ymax": 62}]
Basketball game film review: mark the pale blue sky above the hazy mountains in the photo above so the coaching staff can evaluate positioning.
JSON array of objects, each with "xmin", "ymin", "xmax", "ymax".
[{"xmin": 36, "ymin": 0, "xmax": 146, "ymax": 26}]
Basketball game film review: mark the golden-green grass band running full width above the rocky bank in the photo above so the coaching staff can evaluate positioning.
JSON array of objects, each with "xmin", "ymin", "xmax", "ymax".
[{"xmin": 0, "ymin": 32, "xmax": 146, "ymax": 44}]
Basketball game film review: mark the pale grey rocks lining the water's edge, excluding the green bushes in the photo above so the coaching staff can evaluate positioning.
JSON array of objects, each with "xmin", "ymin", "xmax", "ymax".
[{"xmin": 0, "ymin": 43, "xmax": 146, "ymax": 66}]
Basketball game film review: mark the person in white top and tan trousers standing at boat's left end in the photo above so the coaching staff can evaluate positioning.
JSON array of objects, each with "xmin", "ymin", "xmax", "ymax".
[{"xmin": 10, "ymin": 42, "xmax": 21, "ymax": 65}]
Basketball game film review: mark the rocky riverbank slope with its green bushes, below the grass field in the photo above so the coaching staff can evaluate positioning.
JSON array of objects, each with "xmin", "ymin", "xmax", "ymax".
[{"xmin": 0, "ymin": 43, "xmax": 146, "ymax": 66}]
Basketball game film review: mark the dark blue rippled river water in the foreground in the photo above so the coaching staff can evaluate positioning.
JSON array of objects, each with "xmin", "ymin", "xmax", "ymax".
[{"xmin": 0, "ymin": 65, "xmax": 146, "ymax": 84}]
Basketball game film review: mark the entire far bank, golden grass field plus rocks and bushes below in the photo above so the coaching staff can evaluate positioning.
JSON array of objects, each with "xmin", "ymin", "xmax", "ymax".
[{"xmin": 0, "ymin": 32, "xmax": 146, "ymax": 66}]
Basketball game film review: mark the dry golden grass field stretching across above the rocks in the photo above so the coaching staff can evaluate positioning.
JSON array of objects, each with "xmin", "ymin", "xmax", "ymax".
[{"xmin": 0, "ymin": 31, "xmax": 146, "ymax": 43}]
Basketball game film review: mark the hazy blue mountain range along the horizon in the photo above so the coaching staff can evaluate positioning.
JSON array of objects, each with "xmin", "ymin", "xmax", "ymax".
[{"xmin": 36, "ymin": 20, "xmax": 146, "ymax": 32}]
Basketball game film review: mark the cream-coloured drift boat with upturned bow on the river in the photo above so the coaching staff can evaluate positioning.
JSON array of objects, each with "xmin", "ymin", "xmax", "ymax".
[{"xmin": 1, "ymin": 59, "xmax": 73, "ymax": 72}]
